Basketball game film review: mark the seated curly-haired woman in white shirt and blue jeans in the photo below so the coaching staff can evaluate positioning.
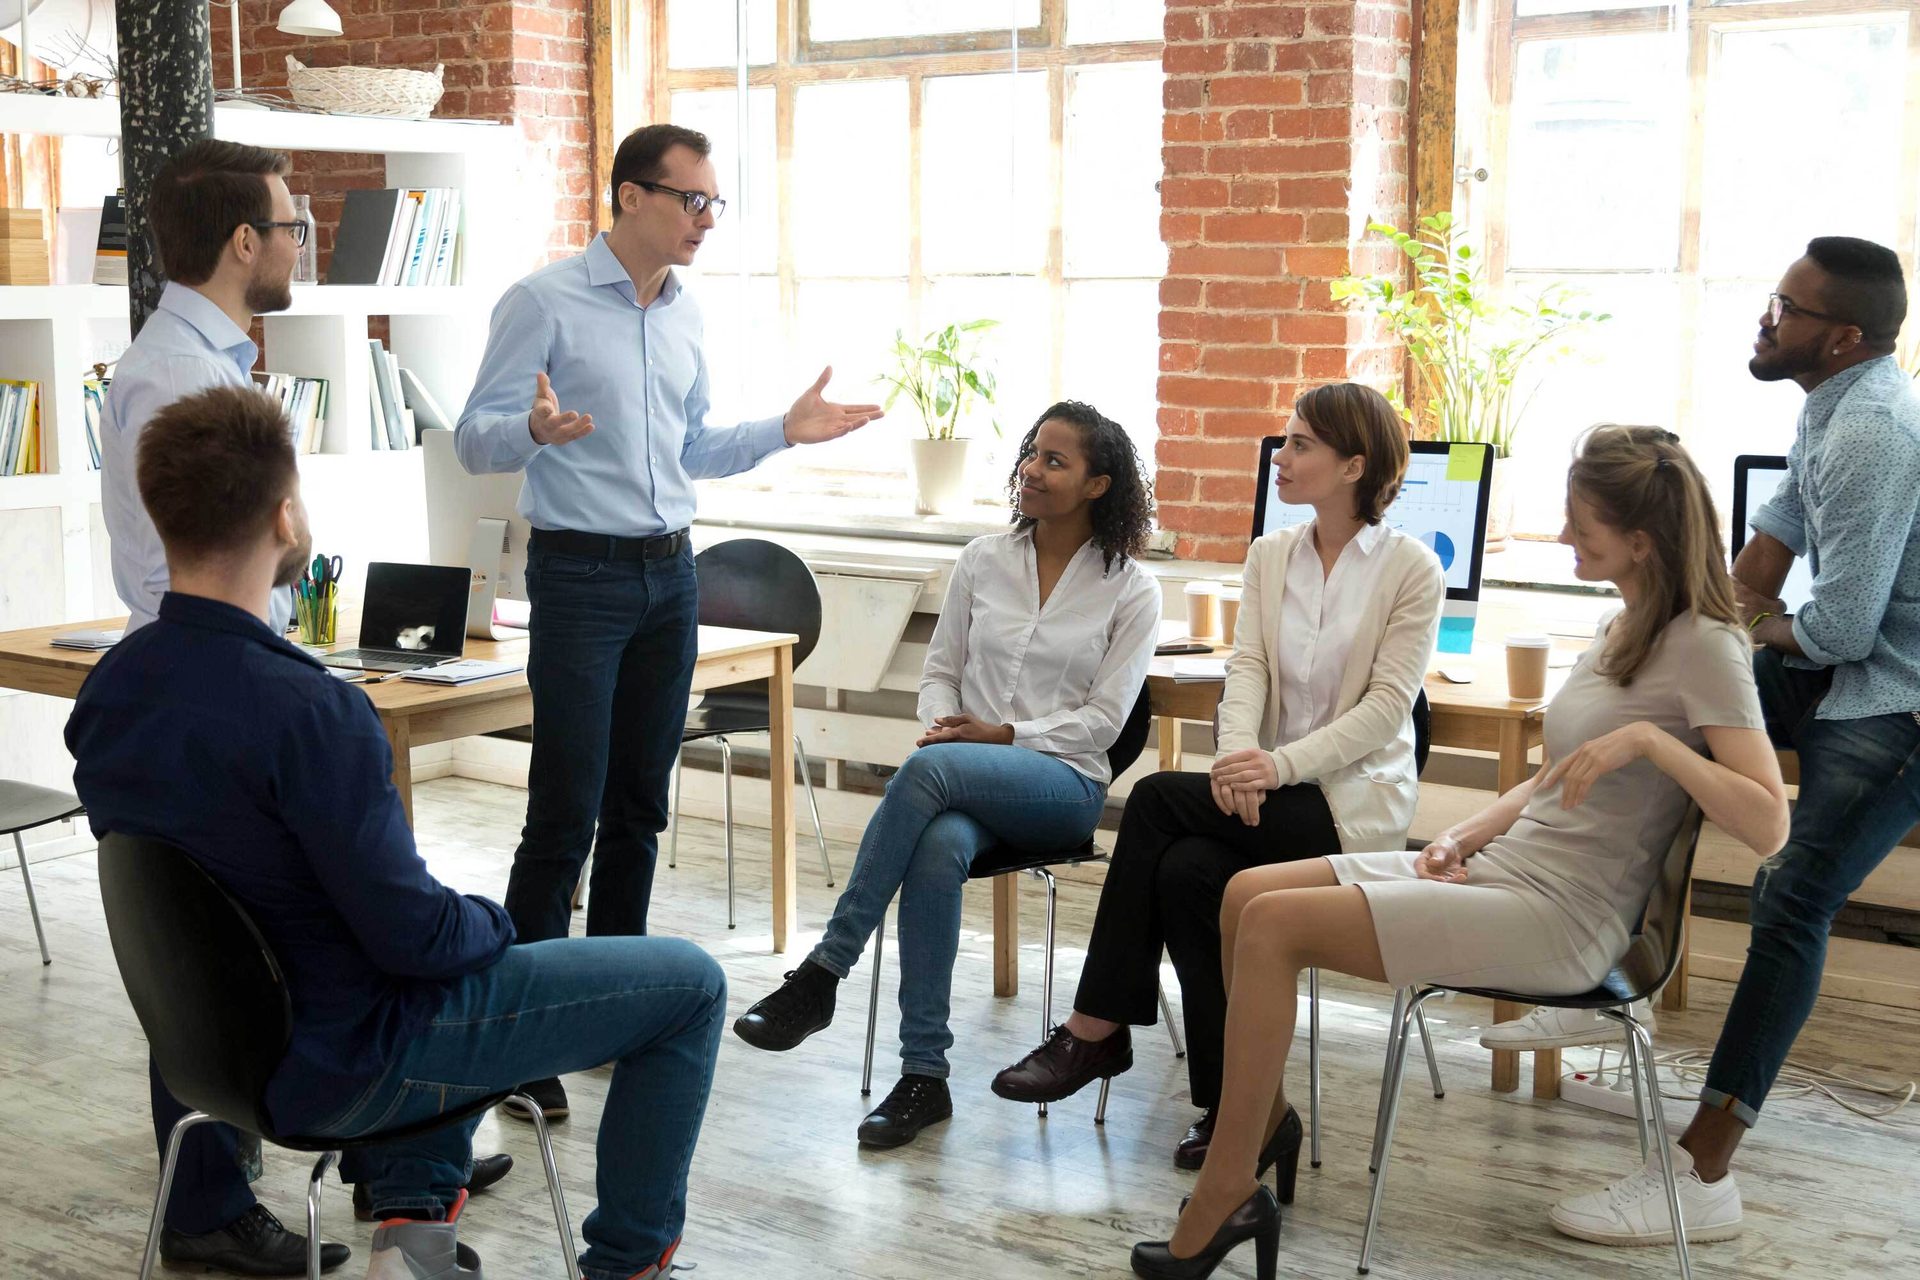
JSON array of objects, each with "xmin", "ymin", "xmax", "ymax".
[{"xmin": 733, "ymin": 401, "xmax": 1160, "ymax": 1146}]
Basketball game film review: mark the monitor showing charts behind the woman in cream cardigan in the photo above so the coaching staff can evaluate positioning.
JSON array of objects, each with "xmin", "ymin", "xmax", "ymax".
[{"xmin": 1254, "ymin": 436, "xmax": 1494, "ymax": 601}]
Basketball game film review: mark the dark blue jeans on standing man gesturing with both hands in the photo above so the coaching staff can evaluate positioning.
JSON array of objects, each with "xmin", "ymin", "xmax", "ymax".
[{"xmin": 507, "ymin": 551, "xmax": 699, "ymax": 942}]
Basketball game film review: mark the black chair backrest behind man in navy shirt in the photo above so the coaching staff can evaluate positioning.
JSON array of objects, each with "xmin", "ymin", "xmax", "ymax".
[{"xmin": 100, "ymin": 833, "xmax": 294, "ymax": 1134}]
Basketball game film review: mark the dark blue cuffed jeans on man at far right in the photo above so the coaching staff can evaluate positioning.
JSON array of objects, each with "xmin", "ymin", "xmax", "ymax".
[{"xmin": 1699, "ymin": 651, "xmax": 1920, "ymax": 1126}]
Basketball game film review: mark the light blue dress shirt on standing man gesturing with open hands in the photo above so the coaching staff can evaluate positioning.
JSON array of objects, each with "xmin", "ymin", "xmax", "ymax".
[{"xmin": 453, "ymin": 232, "xmax": 787, "ymax": 537}]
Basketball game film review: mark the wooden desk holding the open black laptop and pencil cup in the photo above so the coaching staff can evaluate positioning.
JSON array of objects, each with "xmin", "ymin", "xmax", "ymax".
[{"xmin": 0, "ymin": 618, "xmax": 799, "ymax": 952}]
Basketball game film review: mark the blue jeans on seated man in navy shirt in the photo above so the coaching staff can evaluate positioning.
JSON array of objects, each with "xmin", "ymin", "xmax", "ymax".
[{"xmin": 315, "ymin": 938, "xmax": 726, "ymax": 1280}]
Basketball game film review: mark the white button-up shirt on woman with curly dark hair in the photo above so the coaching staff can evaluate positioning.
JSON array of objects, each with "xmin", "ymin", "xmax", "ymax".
[{"xmin": 920, "ymin": 532, "xmax": 1160, "ymax": 785}]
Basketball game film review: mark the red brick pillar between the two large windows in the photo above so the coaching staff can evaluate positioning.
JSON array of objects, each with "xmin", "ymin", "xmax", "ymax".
[{"xmin": 1156, "ymin": 0, "xmax": 1413, "ymax": 560}]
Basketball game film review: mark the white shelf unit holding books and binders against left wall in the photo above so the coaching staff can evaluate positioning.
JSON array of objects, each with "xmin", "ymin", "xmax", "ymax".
[{"xmin": 0, "ymin": 94, "xmax": 529, "ymax": 832}]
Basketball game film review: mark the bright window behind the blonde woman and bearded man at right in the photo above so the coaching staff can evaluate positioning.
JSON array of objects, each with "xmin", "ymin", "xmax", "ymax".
[{"xmin": 1461, "ymin": 0, "xmax": 1920, "ymax": 535}]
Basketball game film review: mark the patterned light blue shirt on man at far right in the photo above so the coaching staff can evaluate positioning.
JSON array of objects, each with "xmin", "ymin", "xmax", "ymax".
[{"xmin": 1753, "ymin": 355, "xmax": 1920, "ymax": 720}]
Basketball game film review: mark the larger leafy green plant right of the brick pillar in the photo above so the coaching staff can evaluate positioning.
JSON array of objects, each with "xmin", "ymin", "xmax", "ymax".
[{"xmin": 1332, "ymin": 213, "xmax": 1611, "ymax": 551}]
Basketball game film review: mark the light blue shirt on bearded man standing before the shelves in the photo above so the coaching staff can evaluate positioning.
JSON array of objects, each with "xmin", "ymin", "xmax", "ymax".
[{"xmin": 100, "ymin": 282, "xmax": 294, "ymax": 635}]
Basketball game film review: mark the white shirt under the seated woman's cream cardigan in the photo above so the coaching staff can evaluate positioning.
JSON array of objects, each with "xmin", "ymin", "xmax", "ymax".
[{"xmin": 1275, "ymin": 524, "xmax": 1386, "ymax": 743}]
